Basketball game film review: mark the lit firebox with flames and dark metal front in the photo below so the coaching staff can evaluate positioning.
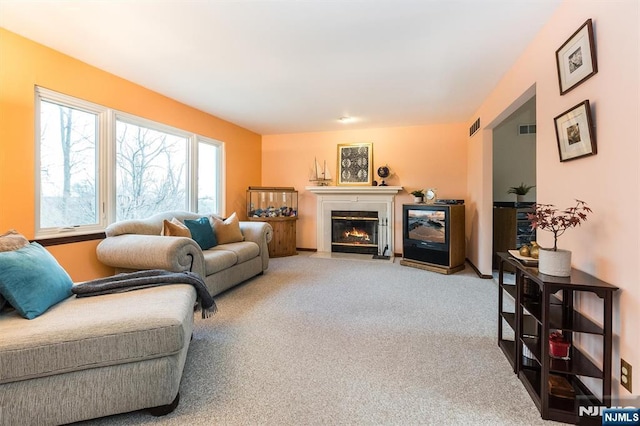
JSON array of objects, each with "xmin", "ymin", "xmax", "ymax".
[{"xmin": 331, "ymin": 210, "xmax": 378, "ymax": 254}]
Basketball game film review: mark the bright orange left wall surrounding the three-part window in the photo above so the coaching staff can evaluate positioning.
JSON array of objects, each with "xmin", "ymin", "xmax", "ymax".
[{"xmin": 0, "ymin": 28, "xmax": 261, "ymax": 281}]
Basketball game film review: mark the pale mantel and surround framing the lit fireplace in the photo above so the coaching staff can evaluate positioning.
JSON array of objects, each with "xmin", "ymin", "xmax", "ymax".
[{"xmin": 305, "ymin": 186, "xmax": 402, "ymax": 258}]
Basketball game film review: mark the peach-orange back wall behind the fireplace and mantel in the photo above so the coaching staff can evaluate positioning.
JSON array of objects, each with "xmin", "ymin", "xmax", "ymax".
[{"xmin": 262, "ymin": 124, "xmax": 467, "ymax": 253}]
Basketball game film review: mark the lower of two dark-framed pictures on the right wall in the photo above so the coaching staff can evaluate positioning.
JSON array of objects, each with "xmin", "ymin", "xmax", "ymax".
[{"xmin": 554, "ymin": 101, "xmax": 597, "ymax": 161}]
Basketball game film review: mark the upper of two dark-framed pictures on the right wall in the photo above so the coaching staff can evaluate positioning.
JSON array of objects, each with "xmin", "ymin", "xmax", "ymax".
[{"xmin": 556, "ymin": 19, "xmax": 598, "ymax": 95}]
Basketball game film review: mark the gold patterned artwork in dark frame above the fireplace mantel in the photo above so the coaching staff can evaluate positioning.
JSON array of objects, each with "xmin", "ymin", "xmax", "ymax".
[{"xmin": 336, "ymin": 143, "xmax": 373, "ymax": 185}]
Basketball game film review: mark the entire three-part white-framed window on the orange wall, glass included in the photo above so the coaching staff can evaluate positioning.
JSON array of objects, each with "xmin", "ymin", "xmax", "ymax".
[{"xmin": 36, "ymin": 88, "xmax": 224, "ymax": 238}]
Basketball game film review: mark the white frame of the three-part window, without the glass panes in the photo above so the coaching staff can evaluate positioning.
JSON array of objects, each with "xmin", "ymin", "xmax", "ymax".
[{"xmin": 35, "ymin": 86, "xmax": 226, "ymax": 239}]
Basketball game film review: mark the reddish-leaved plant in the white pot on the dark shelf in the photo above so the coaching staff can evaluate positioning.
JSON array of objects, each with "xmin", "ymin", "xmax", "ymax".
[{"xmin": 527, "ymin": 200, "xmax": 592, "ymax": 251}]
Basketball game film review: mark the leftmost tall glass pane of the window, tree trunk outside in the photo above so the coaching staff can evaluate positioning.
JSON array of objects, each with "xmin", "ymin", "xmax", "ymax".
[{"xmin": 40, "ymin": 101, "xmax": 98, "ymax": 228}]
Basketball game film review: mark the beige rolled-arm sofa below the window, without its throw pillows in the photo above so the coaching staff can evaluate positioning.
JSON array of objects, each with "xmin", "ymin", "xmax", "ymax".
[{"xmin": 97, "ymin": 211, "xmax": 273, "ymax": 295}]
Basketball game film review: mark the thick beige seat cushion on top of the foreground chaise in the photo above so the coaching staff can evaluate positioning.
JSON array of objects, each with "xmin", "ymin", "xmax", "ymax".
[{"xmin": 0, "ymin": 284, "xmax": 196, "ymax": 383}]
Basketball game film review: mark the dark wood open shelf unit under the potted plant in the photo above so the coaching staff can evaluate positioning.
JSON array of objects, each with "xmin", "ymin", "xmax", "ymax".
[{"xmin": 497, "ymin": 252, "xmax": 618, "ymax": 424}]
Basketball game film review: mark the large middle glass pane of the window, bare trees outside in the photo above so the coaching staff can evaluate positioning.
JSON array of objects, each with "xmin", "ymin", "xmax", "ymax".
[{"xmin": 116, "ymin": 120, "xmax": 188, "ymax": 220}]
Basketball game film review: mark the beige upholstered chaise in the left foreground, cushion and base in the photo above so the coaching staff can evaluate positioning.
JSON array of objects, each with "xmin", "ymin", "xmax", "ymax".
[{"xmin": 0, "ymin": 284, "xmax": 195, "ymax": 426}]
